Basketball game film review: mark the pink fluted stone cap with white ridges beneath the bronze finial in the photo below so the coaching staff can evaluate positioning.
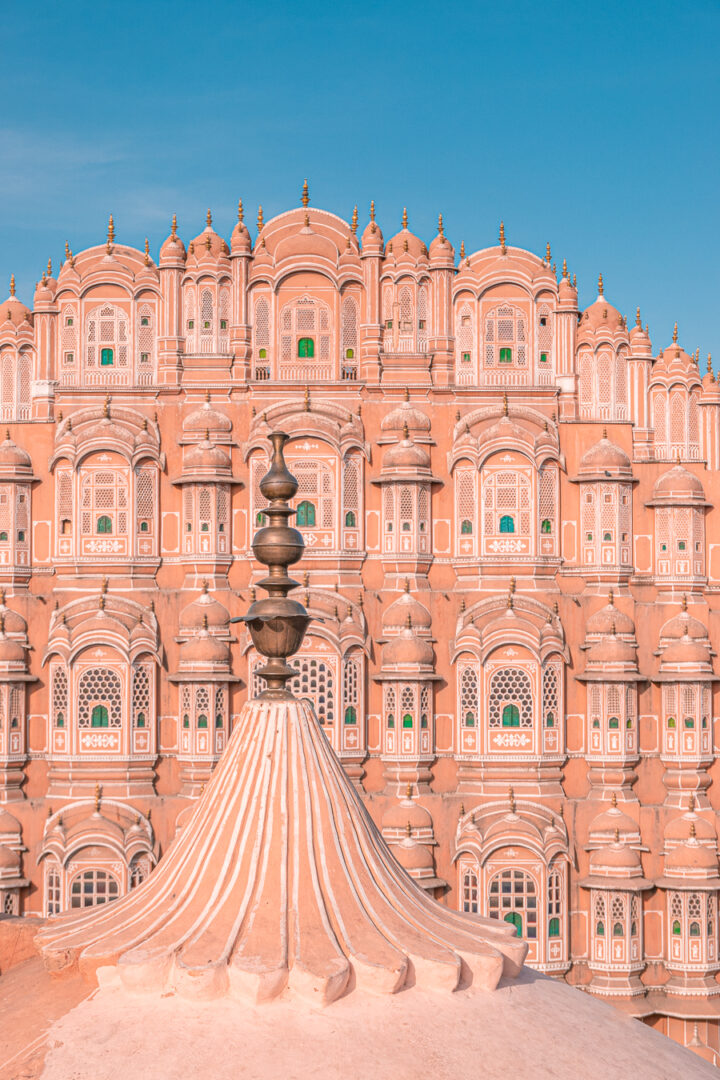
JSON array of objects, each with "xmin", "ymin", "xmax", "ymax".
[{"xmin": 38, "ymin": 700, "xmax": 527, "ymax": 1004}]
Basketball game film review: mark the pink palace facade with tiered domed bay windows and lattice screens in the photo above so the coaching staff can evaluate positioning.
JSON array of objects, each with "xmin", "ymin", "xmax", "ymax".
[{"xmin": 0, "ymin": 188, "xmax": 720, "ymax": 1051}]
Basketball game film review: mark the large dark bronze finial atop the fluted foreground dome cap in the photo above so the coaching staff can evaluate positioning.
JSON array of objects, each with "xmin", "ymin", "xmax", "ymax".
[{"xmin": 231, "ymin": 431, "xmax": 311, "ymax": 701}]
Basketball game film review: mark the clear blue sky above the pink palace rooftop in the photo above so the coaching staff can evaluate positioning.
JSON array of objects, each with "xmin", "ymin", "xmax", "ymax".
[{"xmin": 0, "ymin": 0, "xmax": 720, "ymax": 362}]
